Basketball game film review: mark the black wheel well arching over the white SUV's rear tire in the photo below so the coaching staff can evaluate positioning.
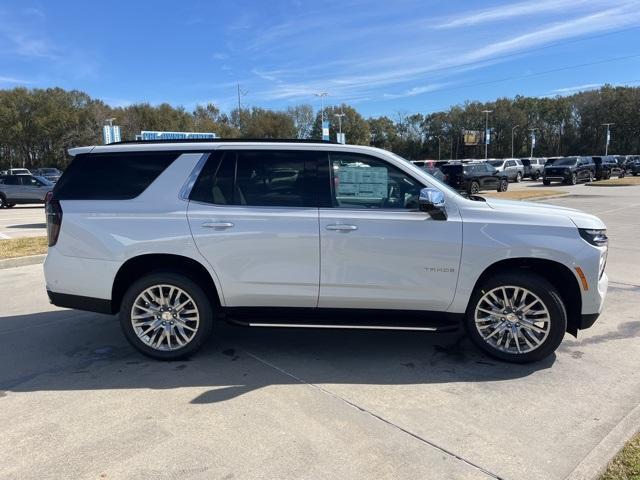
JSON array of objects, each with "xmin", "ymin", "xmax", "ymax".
[{"xmin": 111, "ymin": 254, "xmax": 220, "ymax": 313}]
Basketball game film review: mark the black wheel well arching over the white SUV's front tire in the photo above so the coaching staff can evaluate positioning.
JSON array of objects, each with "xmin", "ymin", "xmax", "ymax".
[{"xmin": 474, "ymin": 258, "xmax": 582, "ymax": 335}]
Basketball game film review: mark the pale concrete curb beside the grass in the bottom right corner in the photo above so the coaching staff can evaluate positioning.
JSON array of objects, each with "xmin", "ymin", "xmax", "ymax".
[{"xmin": 565, "ymin": 405, "xmax": 640, "ymax": 480}]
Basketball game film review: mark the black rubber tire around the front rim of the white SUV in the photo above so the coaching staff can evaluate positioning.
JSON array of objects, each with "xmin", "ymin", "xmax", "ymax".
[{"xmin": 465, "ymin": 272, "xmax": 567, "ymax": 363}]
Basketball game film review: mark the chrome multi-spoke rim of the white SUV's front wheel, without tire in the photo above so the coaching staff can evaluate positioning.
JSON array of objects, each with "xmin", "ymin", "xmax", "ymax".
[{"xmin": 474, "ymin": 286, "xmax": 551, "ymax": 354}]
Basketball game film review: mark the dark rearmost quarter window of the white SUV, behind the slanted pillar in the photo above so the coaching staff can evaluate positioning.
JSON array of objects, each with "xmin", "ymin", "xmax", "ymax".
[{"xmin": 54, "ymin": 152, "xmax": 180, "ymax": 200}]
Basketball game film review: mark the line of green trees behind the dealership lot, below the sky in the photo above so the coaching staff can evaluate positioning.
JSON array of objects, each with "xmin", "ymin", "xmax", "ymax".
[{"xmin": 0, "ymin": 85, "xmax": 640, "ymax": 169}]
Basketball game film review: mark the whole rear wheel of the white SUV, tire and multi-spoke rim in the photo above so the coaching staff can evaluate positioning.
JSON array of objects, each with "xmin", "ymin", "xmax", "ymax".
[{"xmin": 120, "ymin": 271, "xmax": 213, "ymax": 360}]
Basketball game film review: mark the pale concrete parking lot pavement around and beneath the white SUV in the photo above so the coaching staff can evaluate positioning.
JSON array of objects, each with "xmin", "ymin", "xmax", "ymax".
[{"xmin": 0, "ymin": 182, "xmax": 640, "ymax": 480}]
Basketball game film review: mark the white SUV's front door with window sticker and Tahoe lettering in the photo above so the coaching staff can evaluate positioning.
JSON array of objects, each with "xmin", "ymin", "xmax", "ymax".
[{"xmin": 318, "ymin": 152, "xmax": 462, "ymax": 310}]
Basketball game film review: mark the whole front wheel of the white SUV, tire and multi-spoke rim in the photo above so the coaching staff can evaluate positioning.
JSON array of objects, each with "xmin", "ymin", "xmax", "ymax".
[{"xmin": 465, "ymin": 273, "xmax": 567, "ymax": 363}]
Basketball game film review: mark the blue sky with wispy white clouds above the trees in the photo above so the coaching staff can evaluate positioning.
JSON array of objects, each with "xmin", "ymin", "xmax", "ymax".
[{"xmin": 0, "ymin": 0, "xmax": 640, "ymax": 116}]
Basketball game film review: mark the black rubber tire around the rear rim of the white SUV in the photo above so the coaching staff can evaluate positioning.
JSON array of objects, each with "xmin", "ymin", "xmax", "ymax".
[{"xmin": 120, "ymin": 271, "xmax": 213, "ymax": 360}]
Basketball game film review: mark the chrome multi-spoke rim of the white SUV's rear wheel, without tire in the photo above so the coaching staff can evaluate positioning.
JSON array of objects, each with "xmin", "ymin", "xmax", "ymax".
[{"xmin": 131, "ymin": 285, "xmax": 200, "ymax": 351}]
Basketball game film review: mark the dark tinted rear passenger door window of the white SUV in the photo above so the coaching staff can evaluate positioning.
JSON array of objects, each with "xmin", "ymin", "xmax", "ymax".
[{"xmin": 190, "ymin": 150, "xmax": 326, "ymax": 207}]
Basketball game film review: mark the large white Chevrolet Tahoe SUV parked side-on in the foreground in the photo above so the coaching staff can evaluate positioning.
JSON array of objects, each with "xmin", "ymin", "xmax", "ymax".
[{"xmin": 44, "ymin": 140, "xmax": 607, "ymax": 362}]
